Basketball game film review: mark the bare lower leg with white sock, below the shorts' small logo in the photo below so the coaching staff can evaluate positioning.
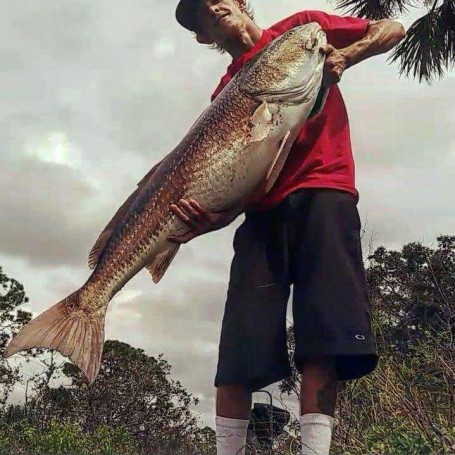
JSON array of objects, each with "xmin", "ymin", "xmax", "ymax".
[{"xmin": 300, "ymin": 356, "xmax": 338, "ymax": 455}]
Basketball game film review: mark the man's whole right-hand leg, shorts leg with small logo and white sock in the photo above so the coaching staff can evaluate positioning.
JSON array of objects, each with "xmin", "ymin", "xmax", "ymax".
[{"xmin": 289, "ymin": 189, "xmax": 377, "ymax": 455}]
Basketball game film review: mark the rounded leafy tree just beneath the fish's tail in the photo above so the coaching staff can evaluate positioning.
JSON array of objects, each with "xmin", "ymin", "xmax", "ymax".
[{"xmin": 45, "ymin": 340, "xmax": 213, "ymax": 454}]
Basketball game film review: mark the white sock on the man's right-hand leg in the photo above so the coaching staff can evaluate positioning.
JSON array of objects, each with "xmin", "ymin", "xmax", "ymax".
[{"xmin": 300, "ymin": 413, "xmax": 335, "ymax": 455}]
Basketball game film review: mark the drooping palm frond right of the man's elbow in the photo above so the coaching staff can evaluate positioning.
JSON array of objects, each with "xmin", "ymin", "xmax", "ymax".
[{"xmin": 390, "ymin": 8, "xmax": 453, "ymax": 83}]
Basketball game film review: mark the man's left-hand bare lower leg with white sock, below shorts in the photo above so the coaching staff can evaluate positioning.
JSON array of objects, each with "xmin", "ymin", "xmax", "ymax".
[{"xmin": 216, "ymin": 385, "xmax": 251, "ymax": 455}]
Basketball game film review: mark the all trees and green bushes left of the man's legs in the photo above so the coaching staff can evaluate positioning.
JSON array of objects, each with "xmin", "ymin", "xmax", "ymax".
[{"xmin": 0, "ymin": 269, "xmax": 215, "ymax": 455}]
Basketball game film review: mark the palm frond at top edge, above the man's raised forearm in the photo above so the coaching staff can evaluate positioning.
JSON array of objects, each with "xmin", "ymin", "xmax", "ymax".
[{"xmin": 336, "ymin": 0, "xmax": 411, "ymax": 20}]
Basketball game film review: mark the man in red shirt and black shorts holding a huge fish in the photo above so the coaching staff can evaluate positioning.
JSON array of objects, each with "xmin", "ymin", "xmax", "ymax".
[{"xmin": 171, "ymin": 0, "xmax": 405, "ymax": 455}]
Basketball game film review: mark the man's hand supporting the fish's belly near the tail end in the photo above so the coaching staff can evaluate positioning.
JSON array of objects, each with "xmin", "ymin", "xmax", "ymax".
[{"xmin": 168, "ymin": 198, "xmax": 241, "ymax": 243}]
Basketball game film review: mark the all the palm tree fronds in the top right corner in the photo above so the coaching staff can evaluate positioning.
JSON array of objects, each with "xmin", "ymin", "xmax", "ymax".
[{"xmin": 335, "ymin": 0, "xmax": 455, "ymax": 82}]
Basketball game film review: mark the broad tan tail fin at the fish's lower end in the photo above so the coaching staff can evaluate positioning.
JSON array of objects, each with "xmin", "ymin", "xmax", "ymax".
[{"xmin": 3, "ymin": 290, "xmax": 104, "ymax": 384}]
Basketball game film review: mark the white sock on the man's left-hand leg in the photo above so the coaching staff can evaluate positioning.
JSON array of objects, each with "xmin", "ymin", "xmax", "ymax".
[{"xmin": 215, "ymin": 416, "xmax": 250, "ymax": 455}]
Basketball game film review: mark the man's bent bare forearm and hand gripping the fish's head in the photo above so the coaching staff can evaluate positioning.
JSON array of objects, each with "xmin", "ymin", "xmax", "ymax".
[{"xmin": 323, "ymin": 19, "xmax": 406, "ymax": 86}]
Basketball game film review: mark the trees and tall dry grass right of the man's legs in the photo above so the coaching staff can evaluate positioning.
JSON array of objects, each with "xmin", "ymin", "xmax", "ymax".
[{"xmin": 280, "ymin": 236, "xmax": 455, "ymax": 455}]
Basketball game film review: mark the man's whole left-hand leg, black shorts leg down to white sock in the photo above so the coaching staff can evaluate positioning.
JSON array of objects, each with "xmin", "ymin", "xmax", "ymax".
[{"xmin": 215, "ymin": 205, "xmax": 292, "ymax": 455}]
